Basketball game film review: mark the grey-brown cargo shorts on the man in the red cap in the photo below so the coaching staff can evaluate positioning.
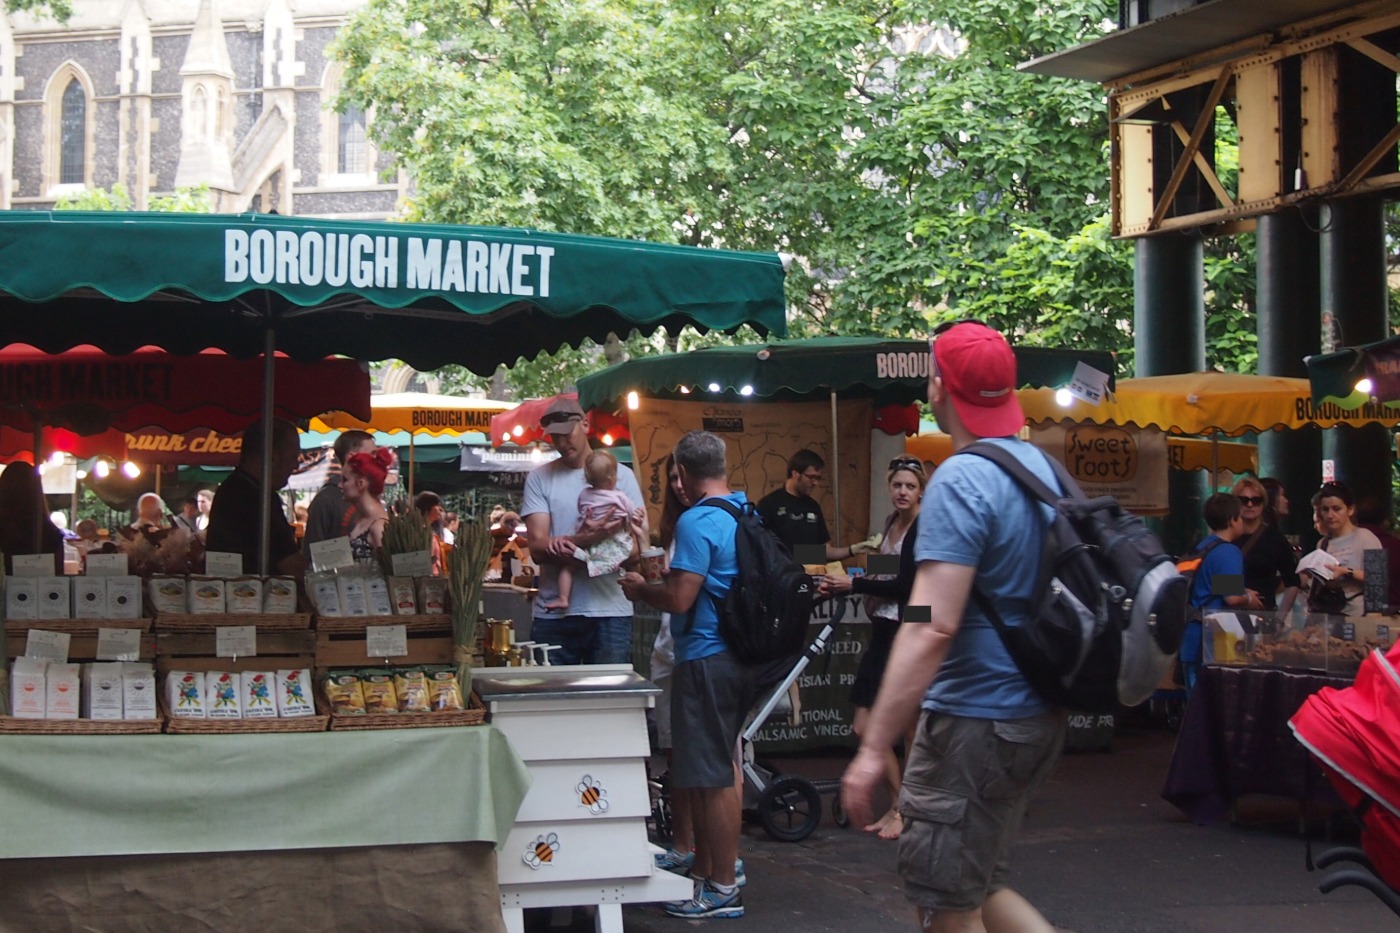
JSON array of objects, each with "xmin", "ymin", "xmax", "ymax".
[{"xmin": 899, "ymin": 712, "xmax": 1065, "ymax": 911}]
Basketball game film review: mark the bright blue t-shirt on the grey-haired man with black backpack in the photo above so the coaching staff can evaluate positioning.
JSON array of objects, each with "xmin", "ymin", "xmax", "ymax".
[{"xmin": 671, "ymin": 492, "xmax": 748, "ymax": 664}]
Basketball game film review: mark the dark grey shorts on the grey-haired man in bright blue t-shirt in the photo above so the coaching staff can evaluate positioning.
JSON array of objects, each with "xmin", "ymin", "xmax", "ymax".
[{"xmin": 671, "ymin": 651, "xmax": 759, "ymax": 787}]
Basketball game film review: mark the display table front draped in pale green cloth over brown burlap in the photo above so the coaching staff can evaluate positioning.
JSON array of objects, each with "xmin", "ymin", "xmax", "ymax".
[{"xmin": 0, "ymin": 726, "xmax": 531, "ymax": 930}]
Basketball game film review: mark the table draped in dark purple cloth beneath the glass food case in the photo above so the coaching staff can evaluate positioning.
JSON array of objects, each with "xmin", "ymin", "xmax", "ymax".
[{"xmin": 1162, "ymin": 664, "xmax": 1351, "ymax": 824}]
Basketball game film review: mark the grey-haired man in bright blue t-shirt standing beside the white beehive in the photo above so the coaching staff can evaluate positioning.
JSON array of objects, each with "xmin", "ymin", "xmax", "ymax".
[{"xmin": 620, "ymin": 431, "xmax": 759, "ymax": 918}]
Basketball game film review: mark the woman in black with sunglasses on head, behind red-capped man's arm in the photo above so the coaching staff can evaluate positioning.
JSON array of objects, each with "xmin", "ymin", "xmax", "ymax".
[{"xmin": 820, "ymin": 457, "xmax": 928, "ymax": 839}]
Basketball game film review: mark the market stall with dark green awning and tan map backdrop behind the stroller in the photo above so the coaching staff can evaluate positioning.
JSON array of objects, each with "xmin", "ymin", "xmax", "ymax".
[{"xmin": 578, "ymin": 338, "xmax": 1114, "ymax": 751}]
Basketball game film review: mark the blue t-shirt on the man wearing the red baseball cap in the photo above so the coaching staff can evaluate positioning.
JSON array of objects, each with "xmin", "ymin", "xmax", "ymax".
[{"xmin": 914, "ymin": 438, "xmax": 1058, "ymax": 719}]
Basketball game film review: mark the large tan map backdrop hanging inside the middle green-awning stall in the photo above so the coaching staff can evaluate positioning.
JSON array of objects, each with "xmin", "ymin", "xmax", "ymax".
[{"xmin": 629, "ymin": 398, "xmax": 874, "ymax": 544}]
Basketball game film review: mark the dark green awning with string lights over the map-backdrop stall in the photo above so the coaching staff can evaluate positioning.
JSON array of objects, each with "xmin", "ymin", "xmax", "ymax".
[{"xmin": 578, "ymin": 336, "xmax": 1116, "ymax": 410}]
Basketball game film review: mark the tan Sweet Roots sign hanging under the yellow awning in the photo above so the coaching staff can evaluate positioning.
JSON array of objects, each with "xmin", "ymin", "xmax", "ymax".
[{"xmin": 1030, "ymin": 424, "xmax": 1169, "ymax": 513}]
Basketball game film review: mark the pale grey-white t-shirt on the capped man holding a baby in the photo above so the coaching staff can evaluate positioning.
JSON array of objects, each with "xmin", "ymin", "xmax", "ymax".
[{"xmin": 521, "ymin": 459, "xmax": 644, "ymax": 619}]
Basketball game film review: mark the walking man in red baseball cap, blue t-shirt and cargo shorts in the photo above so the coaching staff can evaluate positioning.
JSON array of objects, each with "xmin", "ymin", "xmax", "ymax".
[{"xmin": 841, "ymin": 321, "xmax": 1065, "ymax": 933}]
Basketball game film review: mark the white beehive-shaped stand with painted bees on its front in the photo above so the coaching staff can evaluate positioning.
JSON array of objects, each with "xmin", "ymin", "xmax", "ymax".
[{"xmin": 472, "ymin": 664, "xmax": 692, "ymax": 933}]
